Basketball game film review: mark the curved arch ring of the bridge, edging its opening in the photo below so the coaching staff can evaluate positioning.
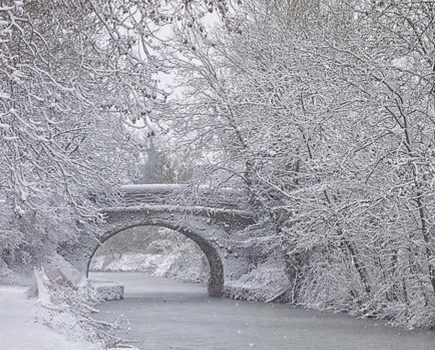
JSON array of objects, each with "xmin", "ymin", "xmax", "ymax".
[{"xmin": 86, "ymin": 217, "xmax": 224, "ymax": 297}]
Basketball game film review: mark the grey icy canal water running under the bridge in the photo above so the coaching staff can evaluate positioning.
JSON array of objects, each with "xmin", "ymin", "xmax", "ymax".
[{"xmin": 91, "ymin": 272, "xmax": 435, "ymax": 350}]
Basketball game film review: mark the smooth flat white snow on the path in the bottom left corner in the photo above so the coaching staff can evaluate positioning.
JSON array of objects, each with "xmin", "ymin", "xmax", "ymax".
[{"xmin": 0, "ymin": 286, "xmax": 101, "ymax": 350}]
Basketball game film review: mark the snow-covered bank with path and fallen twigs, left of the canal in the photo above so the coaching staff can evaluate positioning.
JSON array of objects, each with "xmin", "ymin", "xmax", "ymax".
[{"xmin": 0, "ymin": 255, "xmax": 130, "ymax": 350}]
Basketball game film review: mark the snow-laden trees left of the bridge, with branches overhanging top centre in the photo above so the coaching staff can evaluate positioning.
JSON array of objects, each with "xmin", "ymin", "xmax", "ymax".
[{"xmin": 0, "ymin": 0, "xmax": 242, "ymax": 270}]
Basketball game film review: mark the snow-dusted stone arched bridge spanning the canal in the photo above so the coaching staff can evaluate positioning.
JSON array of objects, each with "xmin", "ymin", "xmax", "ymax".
[{"xmin": 69, "ymin": 184, "xmax": 255, "ymax": 296}]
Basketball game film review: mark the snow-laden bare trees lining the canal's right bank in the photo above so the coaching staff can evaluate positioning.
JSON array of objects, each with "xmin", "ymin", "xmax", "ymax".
[{"xmin": 165, "ymin": 0, "xmax": 435, "ymax": 327}]
